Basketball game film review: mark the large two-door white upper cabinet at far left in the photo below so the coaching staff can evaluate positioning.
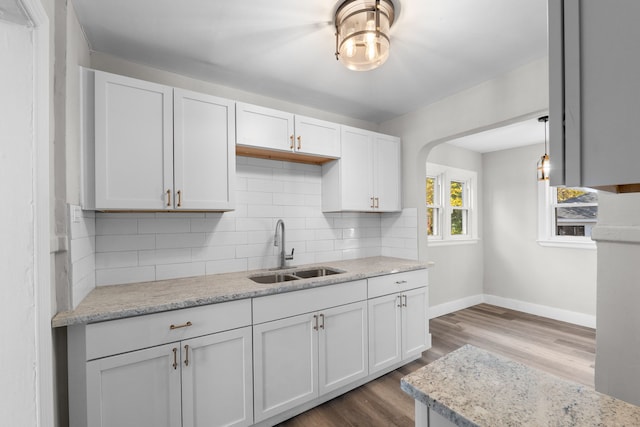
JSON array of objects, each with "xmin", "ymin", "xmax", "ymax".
[{"xmin": 82, "ymin": 69, "xmax": 235, "ymax": 211}]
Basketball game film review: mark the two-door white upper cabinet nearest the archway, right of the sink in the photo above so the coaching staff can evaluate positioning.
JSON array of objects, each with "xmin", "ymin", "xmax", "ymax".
[{"xmin": 322, "ymin": 126, "xmax": 401, "ymax": 212}]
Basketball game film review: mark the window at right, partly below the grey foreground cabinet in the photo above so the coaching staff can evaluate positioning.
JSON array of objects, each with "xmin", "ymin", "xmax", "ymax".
[{"xmin": 538, "ymin": 181, "xmax": 598, "ymax": 249}]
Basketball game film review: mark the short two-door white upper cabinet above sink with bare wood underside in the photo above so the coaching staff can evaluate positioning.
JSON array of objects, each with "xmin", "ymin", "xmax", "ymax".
[{"xmin": 236, "ymin": 102, "xmax": 340, "ymax": 160}]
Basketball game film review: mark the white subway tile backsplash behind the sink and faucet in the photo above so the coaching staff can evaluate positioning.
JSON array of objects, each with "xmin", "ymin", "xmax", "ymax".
[{"xmin": 84, "ymin": 157, "xmax": 417, "ymax": 292}]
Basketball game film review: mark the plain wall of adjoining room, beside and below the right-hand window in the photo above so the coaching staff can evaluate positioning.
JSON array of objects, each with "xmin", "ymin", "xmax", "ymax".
[{"xmin": 482, "ymin": 144, "xmax": 597, "ymax": 316}]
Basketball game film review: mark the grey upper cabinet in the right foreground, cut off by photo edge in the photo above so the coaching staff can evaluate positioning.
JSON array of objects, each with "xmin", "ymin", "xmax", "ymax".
[{"xmin": 549, "ymin": 0, "xmax": 640, "ymax": 191}]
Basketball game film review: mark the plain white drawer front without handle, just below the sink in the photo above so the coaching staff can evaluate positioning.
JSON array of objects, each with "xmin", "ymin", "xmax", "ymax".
[{"xmin": 253, "ymin": 280, "xmax": 367, "ymax": 325}]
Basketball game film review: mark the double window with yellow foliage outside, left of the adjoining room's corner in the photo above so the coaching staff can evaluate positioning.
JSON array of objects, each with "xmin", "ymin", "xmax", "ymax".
[{"xmin": 426, "ymin": 163, "xmax": 477, "ymax": 244}]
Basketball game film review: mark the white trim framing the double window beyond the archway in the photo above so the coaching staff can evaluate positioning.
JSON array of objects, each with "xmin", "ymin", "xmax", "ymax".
[{"xmin": 426, "ymin": 162, "xmax": 479, "ymax": 246}]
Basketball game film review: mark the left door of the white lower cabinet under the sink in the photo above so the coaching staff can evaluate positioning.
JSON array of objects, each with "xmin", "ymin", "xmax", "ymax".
[{"xmin": 253, "ymin": 314, "xmax": 318, "ymax": 422}]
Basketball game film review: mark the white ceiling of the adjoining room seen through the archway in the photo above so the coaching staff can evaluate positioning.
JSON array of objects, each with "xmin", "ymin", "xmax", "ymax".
[{"xmin": 447, "ymin": 118, "xmax": 545, "ymax": 153}]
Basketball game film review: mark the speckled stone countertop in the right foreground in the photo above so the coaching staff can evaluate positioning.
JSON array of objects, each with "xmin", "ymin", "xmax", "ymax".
[{"xmin": 401, "ymin": 345, "xmax": 640, "ymax": 427}]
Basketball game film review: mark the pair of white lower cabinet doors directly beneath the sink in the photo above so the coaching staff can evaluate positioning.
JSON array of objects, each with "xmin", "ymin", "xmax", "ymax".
[{"xmin": 253, "ymin": 301, "xmax": 368, "ymax": 422}]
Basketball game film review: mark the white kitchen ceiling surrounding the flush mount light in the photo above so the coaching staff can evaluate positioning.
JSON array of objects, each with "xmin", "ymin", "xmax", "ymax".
[{"xmin": 73, "ymin": 0, "xmax": 547, "ymax": 122}]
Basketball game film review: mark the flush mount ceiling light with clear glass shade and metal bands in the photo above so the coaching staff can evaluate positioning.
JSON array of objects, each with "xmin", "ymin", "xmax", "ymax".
[{"xmin": 335, "ymin": 0, "xmax": 394, "ymax": 71}]
